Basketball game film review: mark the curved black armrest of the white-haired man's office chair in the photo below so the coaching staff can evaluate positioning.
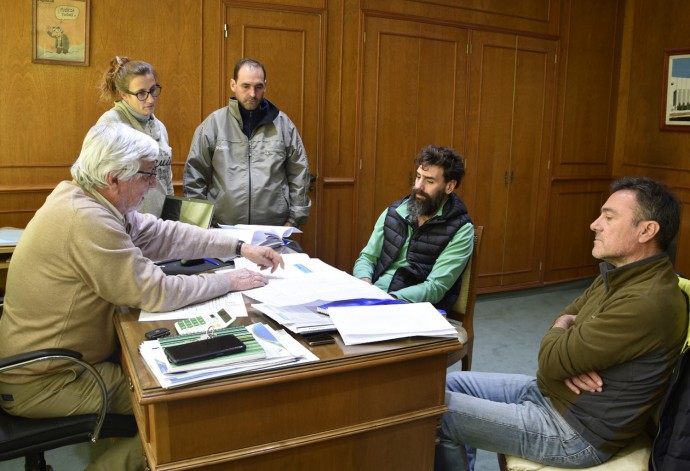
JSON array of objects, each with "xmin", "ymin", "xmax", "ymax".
[{"xmin": 0, "ymin": 348, "xmax": 108, "ymax": 443}]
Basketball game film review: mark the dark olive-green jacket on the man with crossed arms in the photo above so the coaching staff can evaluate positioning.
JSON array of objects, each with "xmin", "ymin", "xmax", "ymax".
[{"xmin": 537, "ymin": 254, "xmax": 688, "ymax": 460}]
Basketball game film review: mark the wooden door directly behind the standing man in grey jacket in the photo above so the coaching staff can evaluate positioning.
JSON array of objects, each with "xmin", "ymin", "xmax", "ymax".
[{"xmin": 221, "ymin": 5, "xmax": 324, "ymax": 257}]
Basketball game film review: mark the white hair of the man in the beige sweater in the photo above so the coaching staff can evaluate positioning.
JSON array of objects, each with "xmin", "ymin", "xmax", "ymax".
[{"xmin": 71, "ymin": 123, "xmax": 159, "ymax": 188}]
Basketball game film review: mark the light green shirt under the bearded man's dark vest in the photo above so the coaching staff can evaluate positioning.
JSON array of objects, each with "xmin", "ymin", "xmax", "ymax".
[{"xmin": 352, "ymin": 200, "xmax": 474, "ymax": 303}]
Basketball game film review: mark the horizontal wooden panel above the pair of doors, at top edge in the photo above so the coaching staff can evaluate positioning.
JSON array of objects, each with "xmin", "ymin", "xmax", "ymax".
[{"xmin": 362, "ymin": 0, "xmax": 561, "ymax": 36}]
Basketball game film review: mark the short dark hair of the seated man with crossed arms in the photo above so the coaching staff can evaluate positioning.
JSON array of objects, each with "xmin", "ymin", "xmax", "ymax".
[{"xmin": 611, "ymin": 177, "xmax": 681, "ymax": 252}]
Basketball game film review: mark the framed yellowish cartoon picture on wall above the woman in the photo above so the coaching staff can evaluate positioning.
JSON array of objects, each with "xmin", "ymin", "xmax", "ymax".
[{"xmin": 32, "ymin": 0, "xmax": 91, "ymax": 66}]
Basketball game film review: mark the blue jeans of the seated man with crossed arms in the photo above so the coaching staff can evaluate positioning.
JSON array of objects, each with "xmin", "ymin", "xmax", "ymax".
[{"xmin": 434, "ymin": 371, "xmax": 608, "ymax": 471}]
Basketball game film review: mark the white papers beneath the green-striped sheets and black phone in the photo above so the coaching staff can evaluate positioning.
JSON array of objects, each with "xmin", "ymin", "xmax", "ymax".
[{"xmin": 139, "ymin": 323, "xmax": 318, "ymax": 389}]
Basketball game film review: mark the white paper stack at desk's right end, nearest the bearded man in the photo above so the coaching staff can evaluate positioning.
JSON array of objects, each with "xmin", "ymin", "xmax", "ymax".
[{"xmin": 328, "ymin": 303, "xmax": 457, "ymax": 345}]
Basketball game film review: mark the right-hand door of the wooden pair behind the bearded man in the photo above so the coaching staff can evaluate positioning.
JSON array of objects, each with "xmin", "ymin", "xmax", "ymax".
[{"xmin": 467, "ymin": 32, "xmax": 556, "ymax": 288}]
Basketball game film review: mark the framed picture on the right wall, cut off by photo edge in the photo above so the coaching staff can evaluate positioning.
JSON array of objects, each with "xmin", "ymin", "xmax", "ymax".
[{"xmin": 660, "ymin": 49, "xmax": 690, "ymax": 131}]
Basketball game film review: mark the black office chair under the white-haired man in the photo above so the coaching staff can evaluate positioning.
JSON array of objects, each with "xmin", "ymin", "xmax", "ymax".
[{"xmin": 0, "ymin": 348, "xmax": 137, "ymax": 471}]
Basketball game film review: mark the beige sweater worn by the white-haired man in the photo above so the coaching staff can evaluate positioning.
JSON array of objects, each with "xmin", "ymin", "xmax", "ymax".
[{"xmin": 0, "ymin": 182, "xmax": 237, "ymax": 383}]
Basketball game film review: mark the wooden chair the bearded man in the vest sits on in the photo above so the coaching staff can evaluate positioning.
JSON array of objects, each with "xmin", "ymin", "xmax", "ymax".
[{"xmin": 447, "ymin": 226, "xmax": 484, "ymax": 371}]
